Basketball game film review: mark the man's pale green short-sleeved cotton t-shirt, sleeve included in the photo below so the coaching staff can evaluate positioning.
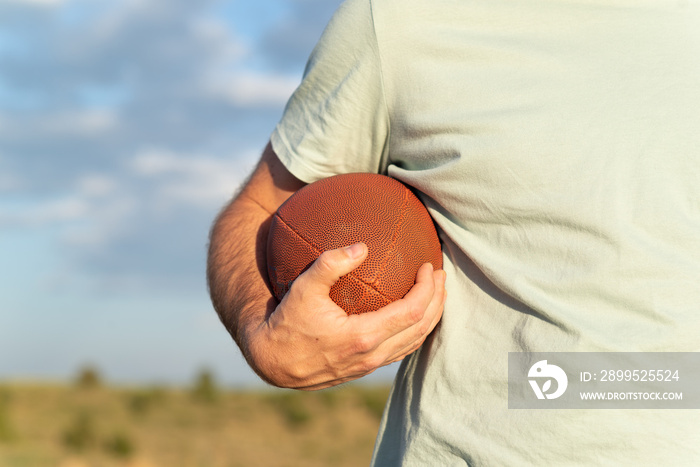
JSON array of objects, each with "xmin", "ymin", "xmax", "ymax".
[{"xmin": 272, "ymin": 0, "xmax": 700, "ymax": 466}]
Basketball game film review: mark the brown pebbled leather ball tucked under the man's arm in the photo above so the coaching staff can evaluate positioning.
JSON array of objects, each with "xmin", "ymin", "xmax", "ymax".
[{"xmin": 267, "ymin": 173, "xmax": 442, "ymax": 314}]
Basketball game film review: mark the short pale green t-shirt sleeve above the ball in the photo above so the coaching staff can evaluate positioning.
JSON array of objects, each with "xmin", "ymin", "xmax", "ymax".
[{"xmin": 271, "ymin": 0, "xmax": 389, "ymax": 183}]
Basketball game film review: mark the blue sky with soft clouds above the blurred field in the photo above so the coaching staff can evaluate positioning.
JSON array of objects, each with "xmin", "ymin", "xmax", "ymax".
[{"xmin": 0, "ymin": 0, "xmax": 400, "ymax": 386}]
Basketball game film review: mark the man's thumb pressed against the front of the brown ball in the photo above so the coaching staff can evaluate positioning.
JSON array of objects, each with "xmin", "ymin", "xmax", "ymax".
[{"xmin": 295, "ymin": 243, "xmax": 367, "ymax": 295}]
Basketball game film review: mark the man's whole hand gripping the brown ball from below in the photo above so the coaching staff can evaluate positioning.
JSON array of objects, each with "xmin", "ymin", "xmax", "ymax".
[{"xmin": 246, "ymin": 243, "xmax": 446, "ymax": 390}]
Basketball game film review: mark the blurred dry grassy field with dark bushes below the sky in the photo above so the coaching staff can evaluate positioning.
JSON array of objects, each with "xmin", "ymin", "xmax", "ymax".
[{"xmin": 0, "ymin": 372, "xmax": 389, "ymax": 467}]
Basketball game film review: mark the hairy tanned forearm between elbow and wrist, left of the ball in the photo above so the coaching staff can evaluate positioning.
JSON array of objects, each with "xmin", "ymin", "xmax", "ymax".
[{"xmin": 207, "ymin": 191, "xmax": 276, "ymax": 371}]
